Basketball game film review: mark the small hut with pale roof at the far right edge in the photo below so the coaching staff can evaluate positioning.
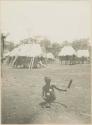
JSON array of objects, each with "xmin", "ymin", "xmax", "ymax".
[{"xmin": 77, "ymin": 50, "xmax": 90, "ymax": 64}]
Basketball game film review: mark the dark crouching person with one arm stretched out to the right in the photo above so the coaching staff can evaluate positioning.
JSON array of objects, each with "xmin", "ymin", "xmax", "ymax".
[{"xmin": 42, "ymin": 77, "xmax": 67, "ymax": 108}]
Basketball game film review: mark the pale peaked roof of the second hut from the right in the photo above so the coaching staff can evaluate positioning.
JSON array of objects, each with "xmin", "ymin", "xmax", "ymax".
[{"xmin": 59, "ymin": 46, "xmax": 76, "ymax": 56}]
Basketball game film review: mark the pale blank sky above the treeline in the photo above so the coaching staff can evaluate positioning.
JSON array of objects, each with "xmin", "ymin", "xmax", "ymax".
[{"xmin": 0, "ymin": 1, "xmax": 91, "ymax": 42}]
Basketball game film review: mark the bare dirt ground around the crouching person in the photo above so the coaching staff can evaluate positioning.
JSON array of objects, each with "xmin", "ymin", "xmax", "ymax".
[{"xmin": 1, "ymin": 64, "xmax": 91, "ymax": 124}]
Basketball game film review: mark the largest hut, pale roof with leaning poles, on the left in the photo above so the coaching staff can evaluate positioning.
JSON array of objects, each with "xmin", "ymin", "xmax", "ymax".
[{"xmin": 5, "ymin": 43, "xmax": 44, "ymax": 69}]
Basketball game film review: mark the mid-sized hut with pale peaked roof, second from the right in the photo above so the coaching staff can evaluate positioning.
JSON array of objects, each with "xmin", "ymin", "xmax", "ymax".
[{"xmin": 58, "ymin": 46, "xmax": 76, "ymax": 64}]
